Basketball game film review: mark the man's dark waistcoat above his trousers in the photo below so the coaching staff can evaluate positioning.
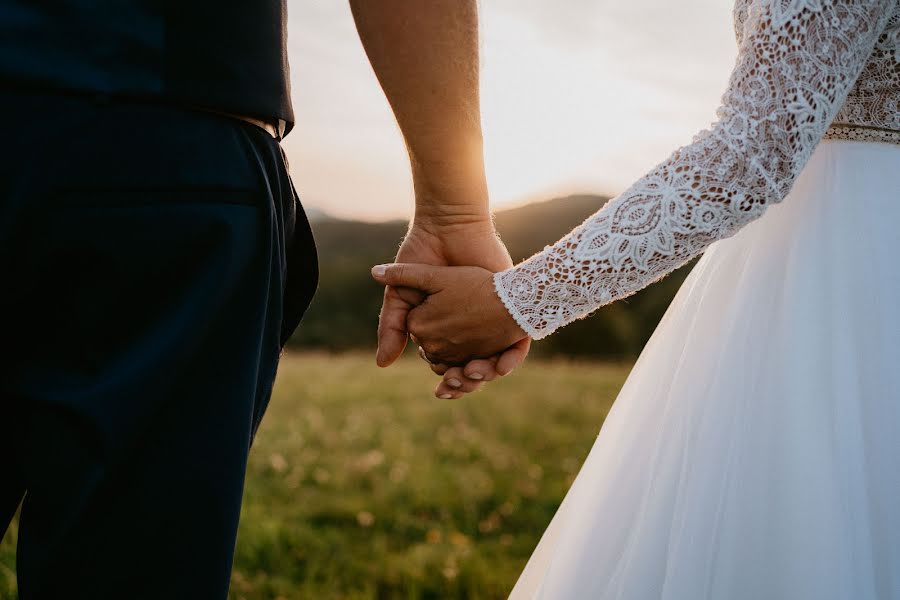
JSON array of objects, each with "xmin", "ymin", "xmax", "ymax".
[{"xmin": 0, "ymin": 0, "xmax": 294, "ymax": 135}]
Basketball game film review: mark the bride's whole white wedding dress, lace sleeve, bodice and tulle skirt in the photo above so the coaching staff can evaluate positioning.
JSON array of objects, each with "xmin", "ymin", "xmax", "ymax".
[{"xmin": 495, "ymin": 0, "xmax": 900, "ymax": 600}]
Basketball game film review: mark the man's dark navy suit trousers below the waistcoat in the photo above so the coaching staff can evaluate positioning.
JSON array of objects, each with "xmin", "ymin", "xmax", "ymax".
[{"xmin": 0, "ymin": 92, "xmax": 317, "ymax": 600}]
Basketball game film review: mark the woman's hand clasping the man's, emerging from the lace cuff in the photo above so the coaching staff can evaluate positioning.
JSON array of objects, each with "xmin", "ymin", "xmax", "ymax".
[{"xmin": 372, "ymin": 263, "xmax": 528, "ymax": 392}]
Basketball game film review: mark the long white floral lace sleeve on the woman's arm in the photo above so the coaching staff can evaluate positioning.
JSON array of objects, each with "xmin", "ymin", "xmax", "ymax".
[{"xmin": 494, "ymin": 0, "xmax": 896, "ymax": 339}]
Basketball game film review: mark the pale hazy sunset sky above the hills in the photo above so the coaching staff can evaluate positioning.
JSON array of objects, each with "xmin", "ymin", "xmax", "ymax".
[{"xmin": 284, "ymin": 0, "xmax": 736, "ymax": 221}]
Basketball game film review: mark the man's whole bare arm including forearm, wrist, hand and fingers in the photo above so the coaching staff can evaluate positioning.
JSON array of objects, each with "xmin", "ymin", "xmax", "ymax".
[{"xmin": 350, "ymin": 0, "xmax": 528, "ymax": 381}]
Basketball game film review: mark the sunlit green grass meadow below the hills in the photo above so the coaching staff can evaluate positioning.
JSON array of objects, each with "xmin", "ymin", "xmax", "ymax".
[{"xmin": 0, "ymin": 354, "xmax": 629, "ymax": 600}]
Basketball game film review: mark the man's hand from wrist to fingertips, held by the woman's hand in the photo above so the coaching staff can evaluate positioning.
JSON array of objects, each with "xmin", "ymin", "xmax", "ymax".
[{"xmin": 377, "ymin": 218, "xmax": 531, "ymax": 382}]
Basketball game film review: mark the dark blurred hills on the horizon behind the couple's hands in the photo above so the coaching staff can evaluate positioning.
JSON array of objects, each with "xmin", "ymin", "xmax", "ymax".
[{"xmin": 290, "ymin": 194, "xmax": 689, "ymax": 358}]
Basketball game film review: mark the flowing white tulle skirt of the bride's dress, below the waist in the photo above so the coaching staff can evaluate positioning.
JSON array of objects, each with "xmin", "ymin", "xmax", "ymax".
[{"xmin": 512, "ymin": 141, "xmax": 900, "ymax": 600}]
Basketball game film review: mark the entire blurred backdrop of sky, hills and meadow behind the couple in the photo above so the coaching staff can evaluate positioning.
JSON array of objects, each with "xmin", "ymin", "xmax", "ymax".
[{"xmin": 0, "ymin": 0, "xmax": 735, "ymax": 600}]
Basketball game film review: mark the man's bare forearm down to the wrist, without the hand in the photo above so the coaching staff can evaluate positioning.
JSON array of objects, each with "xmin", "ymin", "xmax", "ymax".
[{"xmin": 350, "ymin": 0, "xmax": 489, "ymax": 224}]
